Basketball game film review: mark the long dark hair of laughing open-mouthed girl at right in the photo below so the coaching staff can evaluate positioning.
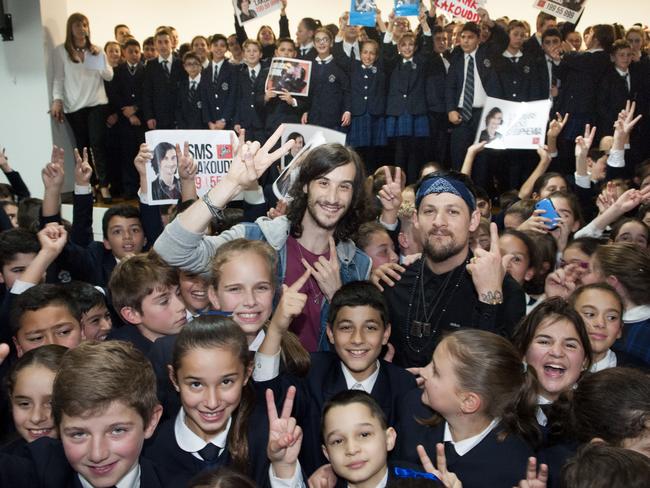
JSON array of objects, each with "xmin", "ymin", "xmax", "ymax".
[{"xmin": 512, "ymin": 297, "xmax": 591, "ymax": 371}]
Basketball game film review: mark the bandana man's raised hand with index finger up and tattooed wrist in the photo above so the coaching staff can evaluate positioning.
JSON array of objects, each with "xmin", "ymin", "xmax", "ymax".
[{"xmin": 467, "ymin": 222, "xmax": 514, "ymax": 305}]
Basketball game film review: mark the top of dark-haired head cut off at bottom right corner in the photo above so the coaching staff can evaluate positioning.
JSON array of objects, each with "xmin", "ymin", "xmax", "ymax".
[{"xmin": 561, "ymin": 442, "xmax": 650, "ymax": 488}]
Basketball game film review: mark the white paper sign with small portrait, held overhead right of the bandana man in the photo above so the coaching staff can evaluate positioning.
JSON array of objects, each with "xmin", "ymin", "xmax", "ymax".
[{"xmin": 474, "ymin": 97, "xmax": 551, "ymax": 149}]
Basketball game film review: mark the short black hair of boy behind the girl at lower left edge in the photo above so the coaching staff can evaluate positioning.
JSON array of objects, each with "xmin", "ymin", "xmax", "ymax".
[{"xmin": 9, "ymin": 283, "xmax": 81, "ymax": 336}]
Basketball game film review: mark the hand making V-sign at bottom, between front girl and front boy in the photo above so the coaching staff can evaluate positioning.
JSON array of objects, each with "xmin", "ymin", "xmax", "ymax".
[{"xmin": 266, "ymin": 386, "xmax": 302, "ymax": 472}]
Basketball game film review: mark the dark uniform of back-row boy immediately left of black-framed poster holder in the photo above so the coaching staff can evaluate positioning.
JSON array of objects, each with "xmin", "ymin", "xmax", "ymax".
[{"xmin": 234, "ymin": 63, "xmax": 269, "ymax": 144}]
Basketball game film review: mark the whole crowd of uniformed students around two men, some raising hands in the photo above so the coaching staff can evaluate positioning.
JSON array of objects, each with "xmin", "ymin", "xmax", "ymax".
[{"xmin": 0, "ymin": 1, "xmax": 650, "ymax": 488}]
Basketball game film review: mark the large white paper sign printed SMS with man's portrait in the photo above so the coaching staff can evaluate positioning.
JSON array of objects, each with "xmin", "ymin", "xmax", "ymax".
[{"xmin": 145, "ymin": 130, "xmax": 241, "ymax": 205}]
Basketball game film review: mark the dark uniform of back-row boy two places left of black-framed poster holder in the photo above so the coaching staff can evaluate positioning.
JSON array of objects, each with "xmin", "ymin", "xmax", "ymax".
[{"xmin": 200, "ymin": 59, "xmax": 239, "ymax": 129}]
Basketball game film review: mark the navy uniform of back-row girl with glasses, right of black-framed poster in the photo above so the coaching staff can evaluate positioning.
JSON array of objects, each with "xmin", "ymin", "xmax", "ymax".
[{"xmin": 308, "ymin": 54, "xmax": 351, "ymax": 132}]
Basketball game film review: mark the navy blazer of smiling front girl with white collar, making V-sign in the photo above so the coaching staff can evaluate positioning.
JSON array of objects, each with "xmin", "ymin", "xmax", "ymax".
[{"xmin": 144, "ymin": 392, "xmax": 270, "ymax": 487}]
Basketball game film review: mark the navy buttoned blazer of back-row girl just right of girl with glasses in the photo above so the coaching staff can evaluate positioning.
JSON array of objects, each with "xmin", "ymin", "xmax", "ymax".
[{"xmin": 350, "ymin": 61, "xmax": 386, "ymax": 116}]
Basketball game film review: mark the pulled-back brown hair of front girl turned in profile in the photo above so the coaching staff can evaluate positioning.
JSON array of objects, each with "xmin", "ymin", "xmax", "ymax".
[{"xmin": 420, "ymin": 329, "xmax": 540, "ymax": 446}]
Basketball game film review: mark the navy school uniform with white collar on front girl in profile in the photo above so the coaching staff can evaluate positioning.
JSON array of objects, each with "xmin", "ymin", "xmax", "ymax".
[{"xmin": 391, "ymin": 390, "xmax": 535, "ymax": 488}]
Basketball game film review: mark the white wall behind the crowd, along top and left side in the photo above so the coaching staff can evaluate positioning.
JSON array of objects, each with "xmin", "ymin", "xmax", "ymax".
[{"xmin": 0, "ymin": 0, "xmax": 650, "ymax": 196}]
